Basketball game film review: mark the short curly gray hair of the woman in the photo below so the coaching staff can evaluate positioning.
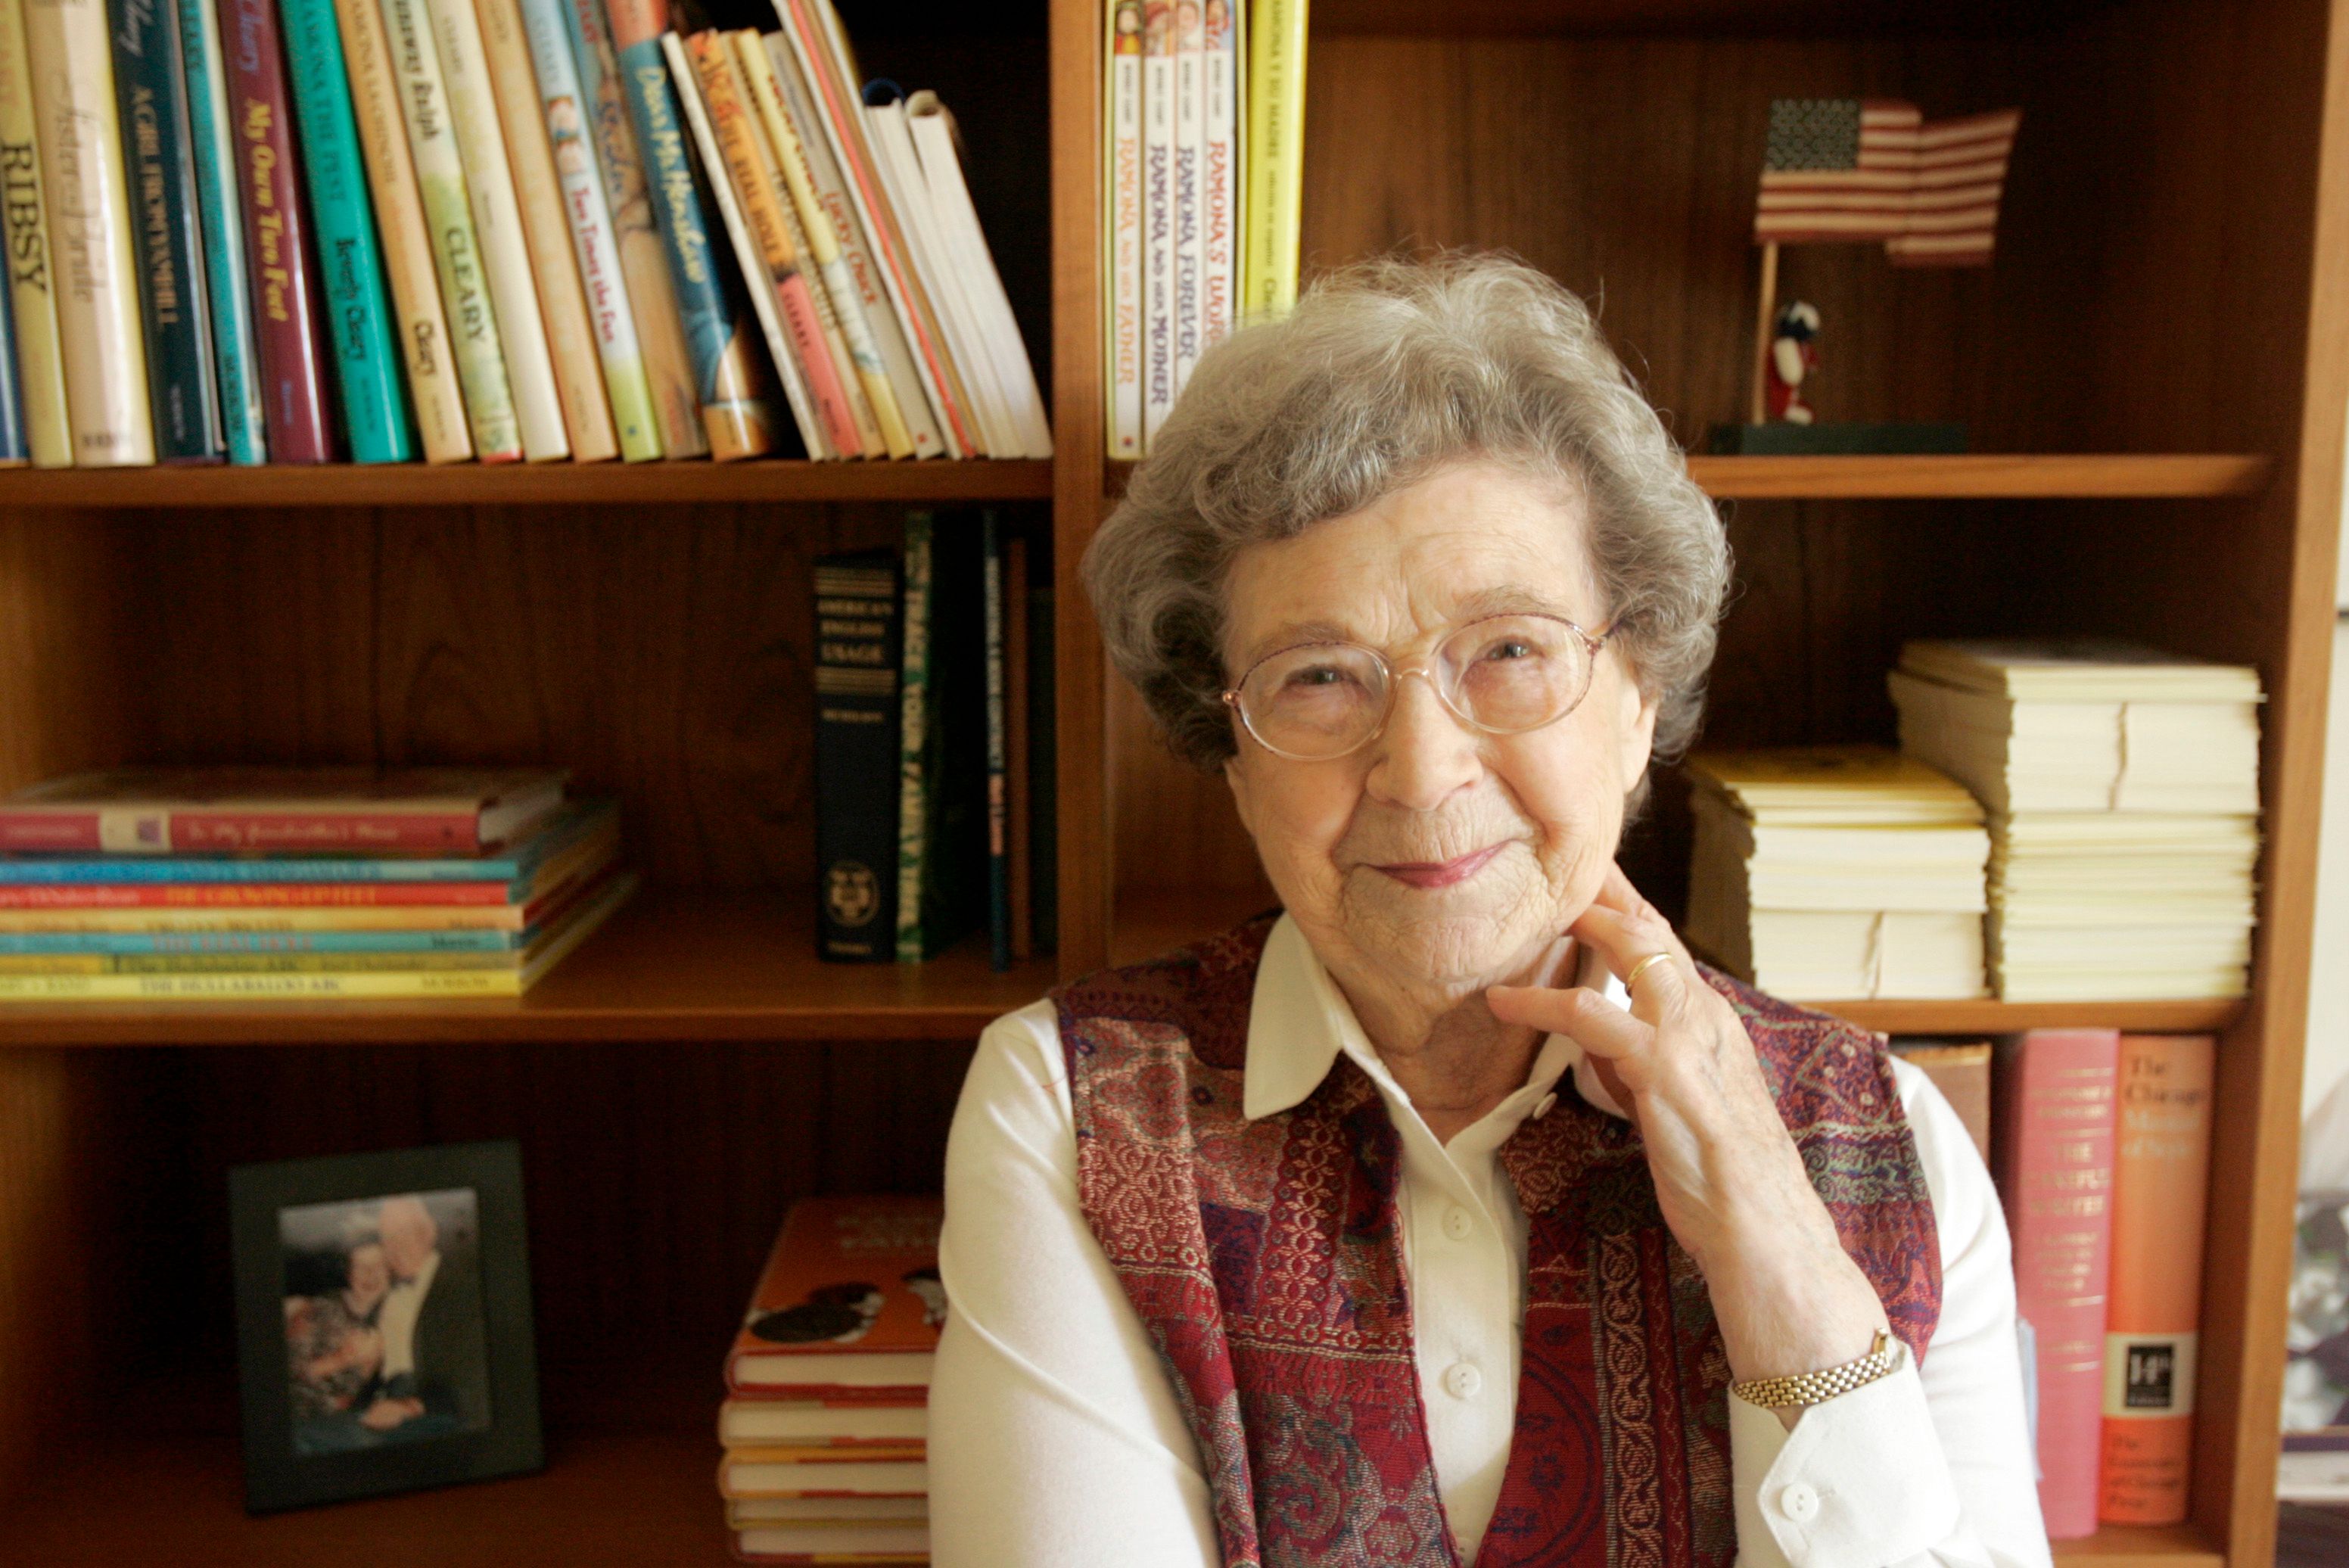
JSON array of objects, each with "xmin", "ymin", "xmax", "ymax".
[{"xmin": 1085, "ymin": 254, "xmax": 1729, "ymax": 770}]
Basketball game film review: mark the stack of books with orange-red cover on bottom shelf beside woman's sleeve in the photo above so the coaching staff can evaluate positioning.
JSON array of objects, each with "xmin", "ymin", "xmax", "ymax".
[{"xmin": 719, "ymin": 1197, "xmax": 947, "ymax": 1563}]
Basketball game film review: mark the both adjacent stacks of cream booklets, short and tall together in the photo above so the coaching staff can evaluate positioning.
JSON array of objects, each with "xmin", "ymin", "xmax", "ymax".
[{"xmin": 1689, "ymin": 641, "xmax": 2260, "ymax": 1002}]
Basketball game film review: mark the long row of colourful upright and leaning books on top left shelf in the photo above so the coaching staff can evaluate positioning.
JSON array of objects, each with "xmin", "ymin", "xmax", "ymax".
[{"xmin": 0, "ymin": 0, "xmax": 1053, "ymax": 467}]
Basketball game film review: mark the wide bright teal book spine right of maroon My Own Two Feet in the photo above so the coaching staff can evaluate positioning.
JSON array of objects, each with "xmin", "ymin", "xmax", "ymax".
[{"xmin": 279, "ymin": 0, "xmax": 415, "ymax": 462}]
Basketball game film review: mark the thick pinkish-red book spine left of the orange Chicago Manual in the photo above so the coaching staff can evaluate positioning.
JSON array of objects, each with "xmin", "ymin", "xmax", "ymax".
[{"xmin": 1992, "ymin": 1028, "xmax": 2119, "ymax": 1540}]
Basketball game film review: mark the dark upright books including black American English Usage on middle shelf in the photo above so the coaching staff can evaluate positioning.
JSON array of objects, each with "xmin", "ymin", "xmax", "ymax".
[{"xmin": 815, "ymin": 509, "xmax": 1059, "ymax": 969}]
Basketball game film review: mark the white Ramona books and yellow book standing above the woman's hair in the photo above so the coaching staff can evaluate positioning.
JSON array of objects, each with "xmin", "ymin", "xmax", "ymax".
[{"xmin": 1102, "ymin": 0, "xmax": 1306, "ymax": 458}]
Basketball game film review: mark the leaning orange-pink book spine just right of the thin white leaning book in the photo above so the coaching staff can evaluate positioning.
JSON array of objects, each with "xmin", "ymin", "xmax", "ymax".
[{"xmin": 686, "ymin": 33, "xmax": 864, "ymax": 458}]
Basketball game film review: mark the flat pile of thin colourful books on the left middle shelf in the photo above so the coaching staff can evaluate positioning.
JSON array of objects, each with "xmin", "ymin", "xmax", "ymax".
[{"xmin": 0, "ymin": 767, "xmax": 636, "ymax": 1002}]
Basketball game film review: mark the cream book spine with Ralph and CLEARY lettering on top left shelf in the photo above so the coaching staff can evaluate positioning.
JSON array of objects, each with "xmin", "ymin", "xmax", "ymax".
[{"xmin": 383, "ymin": 0, "xmax": 521, "ymax": 462}]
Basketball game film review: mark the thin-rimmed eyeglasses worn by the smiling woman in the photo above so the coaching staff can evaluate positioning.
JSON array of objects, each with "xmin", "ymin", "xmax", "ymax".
[{"xmin": 1224, "ymin": 615, "xmax": 1611, "ymax": 763}]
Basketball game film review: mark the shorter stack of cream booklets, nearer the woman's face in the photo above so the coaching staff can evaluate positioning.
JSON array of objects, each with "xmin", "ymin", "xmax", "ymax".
[{"xmin": 1689, "ymin": 746, "xmax": 1990, "ymax": 997}]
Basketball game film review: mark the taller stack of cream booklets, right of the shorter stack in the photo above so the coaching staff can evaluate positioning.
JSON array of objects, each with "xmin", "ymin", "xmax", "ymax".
[{"xmin": 1891, "ymin": 639, "xmax": 2262, "ymax": 1002}]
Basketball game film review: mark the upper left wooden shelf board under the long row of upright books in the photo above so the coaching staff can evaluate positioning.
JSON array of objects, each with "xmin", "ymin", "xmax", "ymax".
[{"xmin": 0, "ymin": 460, "xmax": 1053, "ymax": 509}]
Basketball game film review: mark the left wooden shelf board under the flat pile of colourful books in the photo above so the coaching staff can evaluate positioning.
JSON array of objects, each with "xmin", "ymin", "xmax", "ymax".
[{"xmin": 0, "ymin": 890, "xmax": 1053, "ymax": 1047}]
